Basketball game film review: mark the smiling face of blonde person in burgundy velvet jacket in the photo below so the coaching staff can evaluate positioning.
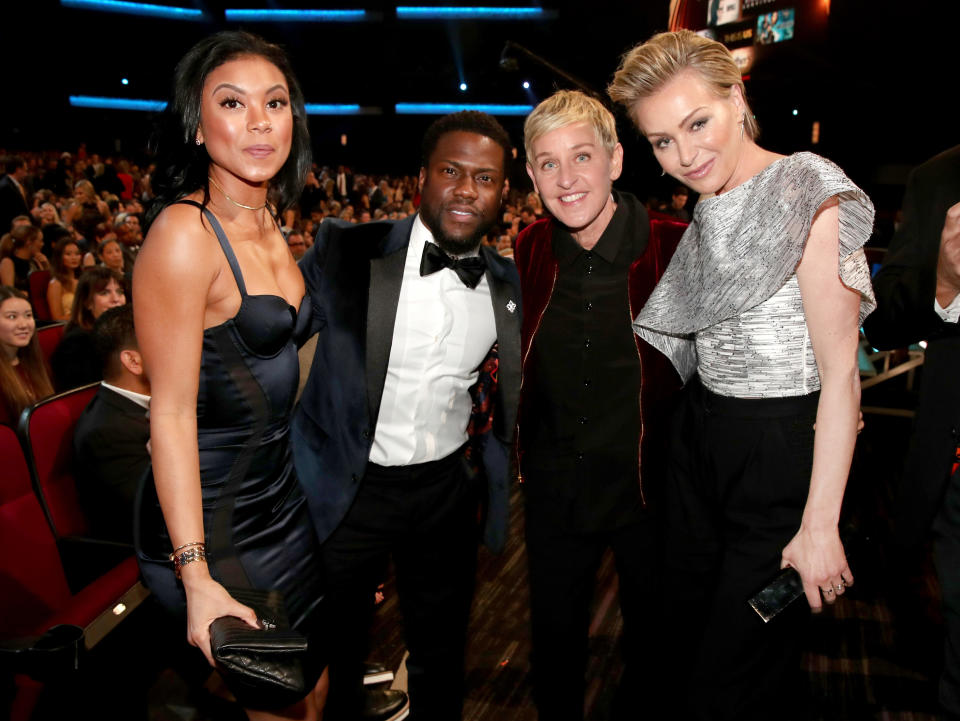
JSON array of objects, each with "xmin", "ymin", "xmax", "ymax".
[{"xmin": 527, "ymin": 122, "xmax": 623, "ymax": 244}]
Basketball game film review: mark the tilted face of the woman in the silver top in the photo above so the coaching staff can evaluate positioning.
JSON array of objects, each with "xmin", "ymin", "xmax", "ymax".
[{"xmin": 632, "ymin": 70, "xmax": 750, "ymax": 195}]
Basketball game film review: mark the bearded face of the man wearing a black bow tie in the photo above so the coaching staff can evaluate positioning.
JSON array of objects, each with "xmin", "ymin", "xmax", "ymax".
[{"xmin": 420, "ymin": 130, "xmax": 504, "ymax": 255}]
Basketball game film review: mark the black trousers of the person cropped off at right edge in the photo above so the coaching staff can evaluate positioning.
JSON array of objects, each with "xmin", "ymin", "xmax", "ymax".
[{"xmin": 933, "ymin": 470, "xmax": 960, "ymax": 719}]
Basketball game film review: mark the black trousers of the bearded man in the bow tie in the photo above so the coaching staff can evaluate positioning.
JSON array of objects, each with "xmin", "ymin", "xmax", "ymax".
[{"xmin": 322, "ymin": 451, "xmax": 479, "ymax": 721}]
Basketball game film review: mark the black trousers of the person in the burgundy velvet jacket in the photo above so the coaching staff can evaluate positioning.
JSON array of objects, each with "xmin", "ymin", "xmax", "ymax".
[{"xmin": 526, "ymin": 495, "xmax": 660, "ymax": 721}]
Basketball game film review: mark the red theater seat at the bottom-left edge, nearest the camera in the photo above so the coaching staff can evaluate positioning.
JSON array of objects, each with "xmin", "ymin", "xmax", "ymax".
[{"xmin": 0, "ymin": 426, "xmax": 148, "ymax": 721}]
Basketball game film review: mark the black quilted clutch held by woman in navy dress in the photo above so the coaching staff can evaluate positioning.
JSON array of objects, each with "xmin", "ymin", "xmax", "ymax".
[{"xmin": 210, "ymin": 588, "xmax": 316, "ymax": 710}]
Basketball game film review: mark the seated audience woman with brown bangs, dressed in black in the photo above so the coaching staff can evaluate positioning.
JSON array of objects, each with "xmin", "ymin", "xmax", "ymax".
[{"xmin": 50, "ymin": 266, "xmax": 127, "ymax": 391}]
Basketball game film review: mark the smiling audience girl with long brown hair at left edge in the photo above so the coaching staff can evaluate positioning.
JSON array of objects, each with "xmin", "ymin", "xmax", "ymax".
[{"xmin": 0, "ymin": 285, "xmax": 53, "ymax": 425}]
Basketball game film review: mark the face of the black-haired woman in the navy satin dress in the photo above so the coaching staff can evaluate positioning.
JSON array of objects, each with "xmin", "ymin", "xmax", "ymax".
[{"xmin": 197, "ymin": 55, "xmax": 293, "ymax": 185}]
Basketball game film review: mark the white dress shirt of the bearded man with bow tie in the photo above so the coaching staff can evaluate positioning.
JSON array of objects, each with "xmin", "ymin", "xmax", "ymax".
[{"xmin": 370, "ymin": 215, "xmax": 497, "ymax": 466}]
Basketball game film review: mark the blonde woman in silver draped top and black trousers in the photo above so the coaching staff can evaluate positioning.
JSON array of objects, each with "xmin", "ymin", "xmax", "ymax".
[{"xmin": 609, "ymin": 31, "xmax": 875, "ymax": 721}]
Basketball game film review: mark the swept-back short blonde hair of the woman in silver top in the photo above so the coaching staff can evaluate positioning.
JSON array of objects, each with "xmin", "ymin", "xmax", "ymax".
[{"xmin": 607, "ymin": 30, "xmax": 760, "ymax": 139}]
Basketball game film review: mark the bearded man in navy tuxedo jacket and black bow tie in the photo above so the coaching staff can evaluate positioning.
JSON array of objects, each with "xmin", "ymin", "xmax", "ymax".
[{"xmin": 292, "ymin": 112, "xmax": 520, "ymax": 721}]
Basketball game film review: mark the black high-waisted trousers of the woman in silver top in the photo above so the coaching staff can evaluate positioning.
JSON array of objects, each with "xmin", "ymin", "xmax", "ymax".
[{"xmin": 665, "ymin": 386, "xmax": 819, "ymax": 721}]
